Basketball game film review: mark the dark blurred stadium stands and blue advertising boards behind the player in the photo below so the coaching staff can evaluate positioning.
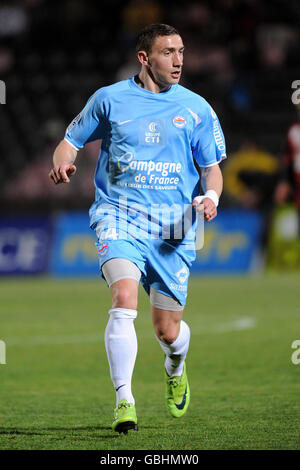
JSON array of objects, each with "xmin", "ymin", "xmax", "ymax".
[{"xmin": 0, "ymin": 0, "xmax": 300, "ymax": 275}]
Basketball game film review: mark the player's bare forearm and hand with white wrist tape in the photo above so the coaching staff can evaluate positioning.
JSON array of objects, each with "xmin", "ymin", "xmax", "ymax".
[{"xmin": 192, "ymin": 165, "xmax": 223, "ymax": 222}]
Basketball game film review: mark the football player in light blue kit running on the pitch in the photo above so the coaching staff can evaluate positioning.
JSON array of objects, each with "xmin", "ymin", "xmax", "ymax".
[{"xmin": 49, "ymin": 24, "xmax": 226, "ymax": 433}]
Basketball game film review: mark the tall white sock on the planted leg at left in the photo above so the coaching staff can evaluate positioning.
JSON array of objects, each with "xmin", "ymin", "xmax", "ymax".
[{"xmin": 105, "ymin": 308, "xmax": 137, "ymax": 406}]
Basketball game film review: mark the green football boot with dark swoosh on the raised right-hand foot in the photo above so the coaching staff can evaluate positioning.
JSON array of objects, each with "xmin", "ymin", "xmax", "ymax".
[{"xmin": 165, "ymin": 363, "xmax": 190, "ymax": 418}]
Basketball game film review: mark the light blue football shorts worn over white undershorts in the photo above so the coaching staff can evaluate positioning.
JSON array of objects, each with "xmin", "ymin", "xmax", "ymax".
[{"xmin": 96, "ymin": 236, "xmax": 190, "ymax": 306}]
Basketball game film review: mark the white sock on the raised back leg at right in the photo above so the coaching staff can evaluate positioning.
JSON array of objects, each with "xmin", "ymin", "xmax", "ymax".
[{"xmin": 157, "ymin": 320, "xmax": 190, "ymax": 377}]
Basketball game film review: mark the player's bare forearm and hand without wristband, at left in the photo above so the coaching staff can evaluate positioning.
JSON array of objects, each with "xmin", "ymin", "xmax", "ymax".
[{"xmin": 49, "ymin": 140, "xmax": 77, "ymax": 184}]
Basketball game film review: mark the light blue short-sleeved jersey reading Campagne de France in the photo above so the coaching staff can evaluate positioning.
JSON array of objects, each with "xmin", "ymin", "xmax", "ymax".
[{"xmin": 65, "ymin": 77, "xmax": 226, "ymax": 302}]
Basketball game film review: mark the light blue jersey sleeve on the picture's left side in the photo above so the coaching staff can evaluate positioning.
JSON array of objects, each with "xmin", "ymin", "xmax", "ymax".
[{"xmin": 65, "ymin": 89, "xmax": 107, "ymax": 150}]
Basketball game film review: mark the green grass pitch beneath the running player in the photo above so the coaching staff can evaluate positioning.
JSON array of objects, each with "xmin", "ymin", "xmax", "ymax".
[{"xmin": 0, "ymin": 274, "xmax": 300, "ymax": 450}]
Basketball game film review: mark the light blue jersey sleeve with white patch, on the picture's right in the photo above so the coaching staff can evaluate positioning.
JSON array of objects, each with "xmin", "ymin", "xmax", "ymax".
[{"xmin": 191, "ymin": 103, "xmax": 226, "ymax": 168}]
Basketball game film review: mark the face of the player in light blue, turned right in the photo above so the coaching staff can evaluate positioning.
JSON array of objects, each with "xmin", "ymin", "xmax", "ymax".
[{"xmin": 148, "ymin": 34, "xmax": 184, "ymax": 86}]
